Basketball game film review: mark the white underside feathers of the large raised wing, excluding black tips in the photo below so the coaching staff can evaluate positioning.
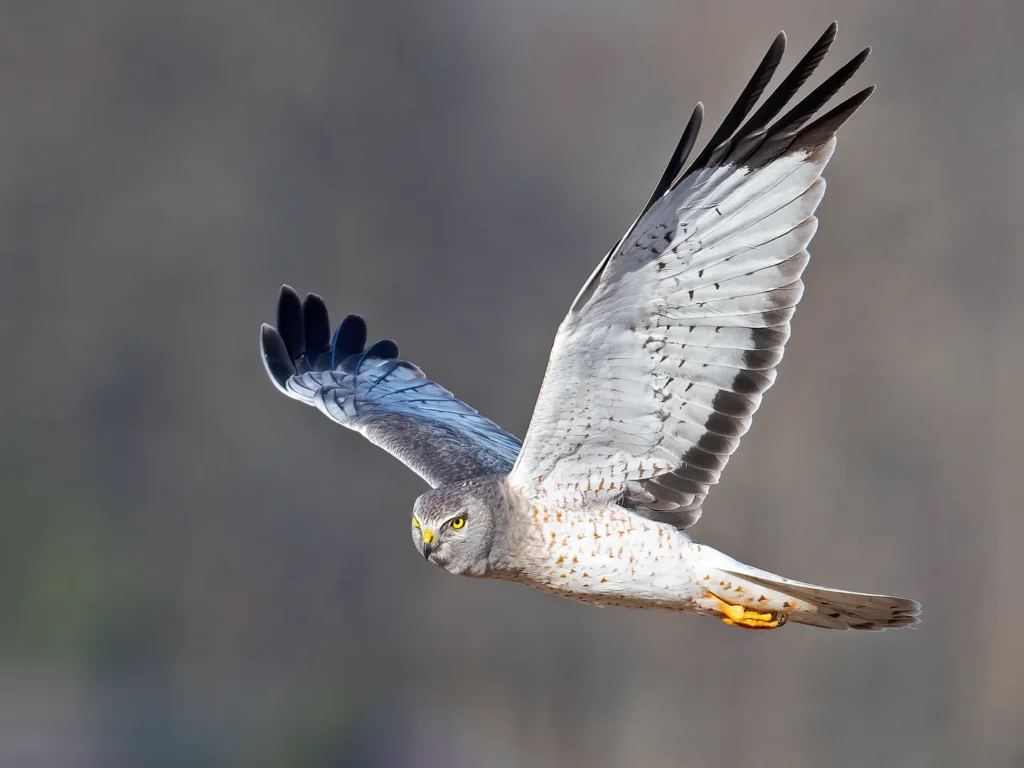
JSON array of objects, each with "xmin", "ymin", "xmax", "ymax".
[{"xmin": 510, "ymin": 138, "xmax": 835, "ymax": 524}]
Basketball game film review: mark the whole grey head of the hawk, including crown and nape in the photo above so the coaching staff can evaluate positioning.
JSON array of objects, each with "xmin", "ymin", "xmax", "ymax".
[{"xmin": 412, "ymin": 477, "xmax": 508, "ymax": 577}]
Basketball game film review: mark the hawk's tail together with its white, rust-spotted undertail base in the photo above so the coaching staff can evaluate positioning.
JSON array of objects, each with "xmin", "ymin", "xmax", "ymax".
[{"xmin": 703, "ymin": 547, "xmax": 921, "ymax": 630}]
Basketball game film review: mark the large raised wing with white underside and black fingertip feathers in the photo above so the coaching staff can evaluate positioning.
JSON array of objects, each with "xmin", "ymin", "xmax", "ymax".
[{"xmin": 510, "ymin": 24, "xmax": 872, "ymax": 527}]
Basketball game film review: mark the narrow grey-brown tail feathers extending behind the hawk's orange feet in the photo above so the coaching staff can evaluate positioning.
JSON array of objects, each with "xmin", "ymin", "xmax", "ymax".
[{"xmin": 725, "ymin": 568, "xmax": 921, "ymax": 630}]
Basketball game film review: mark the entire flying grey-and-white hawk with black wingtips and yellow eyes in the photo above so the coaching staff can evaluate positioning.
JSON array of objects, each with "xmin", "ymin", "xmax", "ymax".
[{"xmin": 260, "ymin": 23, "xmax": 921, "ymax": 630}]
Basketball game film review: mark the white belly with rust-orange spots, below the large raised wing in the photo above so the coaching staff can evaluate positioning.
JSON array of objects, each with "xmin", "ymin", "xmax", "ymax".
[{"xmin": 520, "ymin": 507, "xmax": 703, "ymax": 610}]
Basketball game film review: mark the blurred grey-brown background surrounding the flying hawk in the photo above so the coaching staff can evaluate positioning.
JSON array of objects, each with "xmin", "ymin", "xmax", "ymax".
[{"xmin": 0, "ymin": 0, "xmax": 1024, "ymax": 768}]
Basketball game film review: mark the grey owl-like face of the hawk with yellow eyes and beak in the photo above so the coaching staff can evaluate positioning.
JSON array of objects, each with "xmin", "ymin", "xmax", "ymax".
[{"xmin": 412, "ymin": 483, "xmax": 494, "ymax": 575}]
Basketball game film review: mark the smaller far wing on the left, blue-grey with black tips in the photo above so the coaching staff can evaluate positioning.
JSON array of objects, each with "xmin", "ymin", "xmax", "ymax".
[{"xmin": 260, "ymin": 286, "xmax": 520, "ymax": 487}]
